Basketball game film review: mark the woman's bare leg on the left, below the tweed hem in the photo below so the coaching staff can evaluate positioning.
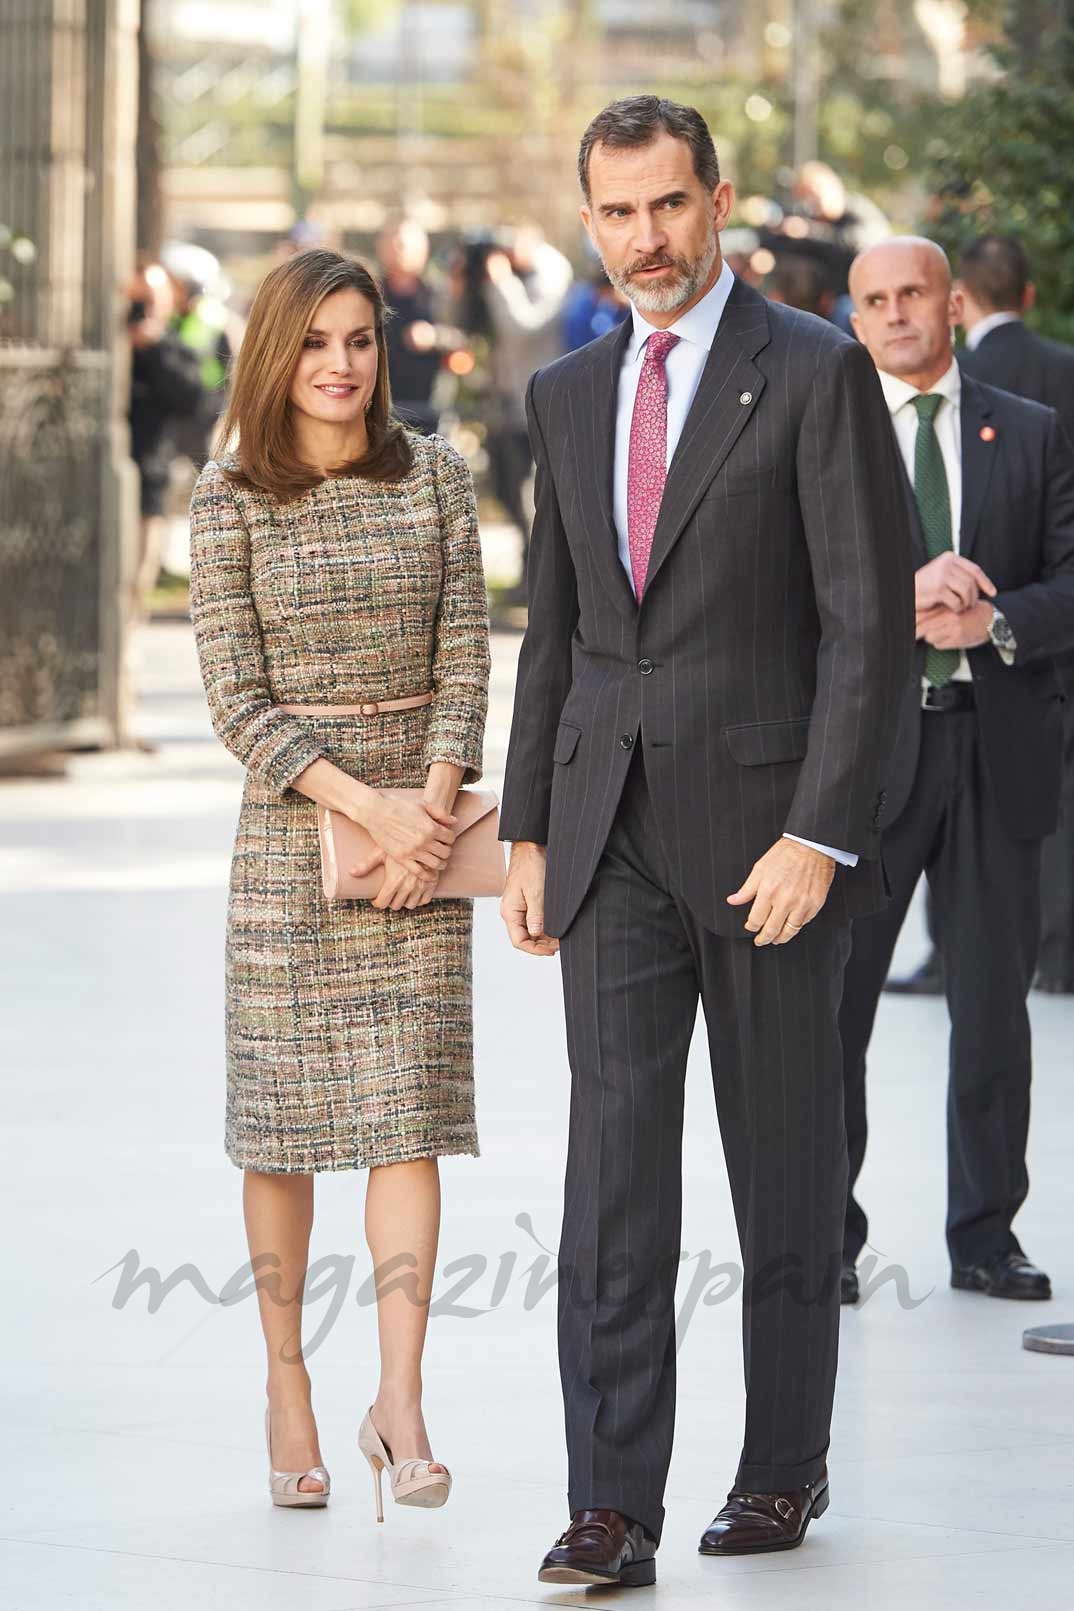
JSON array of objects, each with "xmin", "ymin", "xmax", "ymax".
[{"xmin": 243, "ymin": 1170, "xmax": 324, "ymax": 1493}]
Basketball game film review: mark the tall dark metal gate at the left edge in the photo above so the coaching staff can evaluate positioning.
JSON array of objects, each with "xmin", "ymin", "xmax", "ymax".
[{"xmin": 0, "ymin": 0, "xmax": 138, "ymax": 756}]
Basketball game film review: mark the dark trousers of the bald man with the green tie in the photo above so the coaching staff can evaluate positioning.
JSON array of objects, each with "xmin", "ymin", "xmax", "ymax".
[{"xmin": 839, "ymin": 710, "xmax": 1040, "ymax": 1265}]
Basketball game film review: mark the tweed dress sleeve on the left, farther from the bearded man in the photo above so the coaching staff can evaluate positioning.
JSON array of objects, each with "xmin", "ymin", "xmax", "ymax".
[{"xmin": 190, "ymin": 459, "xmax": 325, "ymax": 794}]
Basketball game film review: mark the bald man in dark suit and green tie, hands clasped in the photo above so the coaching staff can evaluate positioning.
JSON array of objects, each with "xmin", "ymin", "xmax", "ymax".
[{"xmin": 839, "ymin": 238, "xmax": 1074, "ymax": 1298}]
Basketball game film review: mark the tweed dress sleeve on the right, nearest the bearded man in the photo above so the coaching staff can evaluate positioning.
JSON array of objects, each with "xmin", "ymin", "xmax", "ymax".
[{"xmin": 422, "ymin": 437, "xmax": 489, "ymax": 783}]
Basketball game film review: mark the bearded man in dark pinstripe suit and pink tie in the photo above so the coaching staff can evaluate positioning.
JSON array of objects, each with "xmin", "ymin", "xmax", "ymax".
[{"xmin": 501, "ymin": 97, "xmax": 913, "ymax": 1585}]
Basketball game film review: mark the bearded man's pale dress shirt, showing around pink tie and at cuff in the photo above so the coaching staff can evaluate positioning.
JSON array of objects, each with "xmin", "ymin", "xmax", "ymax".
[{"xmin": 612, "ymin": 261, "xmax": 858, "ymax": 867}]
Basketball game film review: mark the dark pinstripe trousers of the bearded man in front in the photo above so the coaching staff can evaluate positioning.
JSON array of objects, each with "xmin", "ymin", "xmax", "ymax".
[{"xmin": 559, "ymin": 743, "xmax": 850, "ymax": 1540}]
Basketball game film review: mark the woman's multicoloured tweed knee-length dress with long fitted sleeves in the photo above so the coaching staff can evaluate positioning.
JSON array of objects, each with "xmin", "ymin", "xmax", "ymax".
[{"xmin": 190, "ymin": 437, "xmax": 489, "ymax": 1174}]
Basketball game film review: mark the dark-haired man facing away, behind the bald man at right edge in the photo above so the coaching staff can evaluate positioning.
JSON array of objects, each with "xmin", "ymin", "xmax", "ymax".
[{"xmin": 958, "ymin": 235, "xmax": 1074, "ymax": 996}]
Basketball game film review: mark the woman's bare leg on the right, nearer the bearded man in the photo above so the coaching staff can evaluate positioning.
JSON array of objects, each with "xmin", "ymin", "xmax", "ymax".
[{"xmin": 366, "ymin": 1158, "xmax": 444, "ymax": 1471}]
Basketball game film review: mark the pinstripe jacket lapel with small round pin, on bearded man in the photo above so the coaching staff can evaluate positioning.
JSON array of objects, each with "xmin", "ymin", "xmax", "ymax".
[{"xmin": 642, "ymin": 279, "xmax": 770, "ymax": 601}]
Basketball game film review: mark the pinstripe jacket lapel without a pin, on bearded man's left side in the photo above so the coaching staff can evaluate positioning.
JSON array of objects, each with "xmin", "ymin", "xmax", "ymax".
[{"xmin": 568, "ymin": 316, "xmax": 638, "ymax": 619}]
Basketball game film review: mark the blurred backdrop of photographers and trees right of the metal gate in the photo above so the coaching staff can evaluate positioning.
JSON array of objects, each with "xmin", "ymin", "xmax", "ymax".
[{"xmin": 94, "ymin": 0, "xmax": 1074, "ymax": 625}]
